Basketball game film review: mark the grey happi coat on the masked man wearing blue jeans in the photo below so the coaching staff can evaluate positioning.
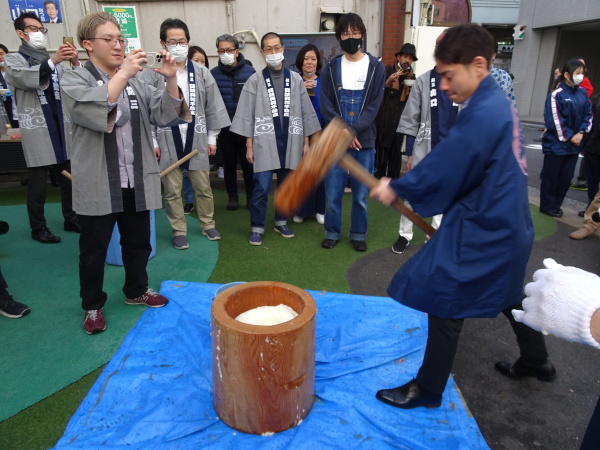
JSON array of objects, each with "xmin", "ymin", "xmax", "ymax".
[{"xmin": 230, "ymin": 71, "xmax": 321, "ymax": 172}]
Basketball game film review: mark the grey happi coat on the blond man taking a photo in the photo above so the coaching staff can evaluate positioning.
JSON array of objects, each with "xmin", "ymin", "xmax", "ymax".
[{"xmin": 61, "ymin": 68, "xmax": 192, "ymax": 216}]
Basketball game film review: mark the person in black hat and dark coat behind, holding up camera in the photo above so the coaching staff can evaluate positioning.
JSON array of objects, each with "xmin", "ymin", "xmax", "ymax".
[{"xmin": 375, "ymin": 43, "xmax": 417, "ymax": 178}]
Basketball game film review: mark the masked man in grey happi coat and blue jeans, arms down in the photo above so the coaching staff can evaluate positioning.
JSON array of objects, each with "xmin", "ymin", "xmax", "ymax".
[{"xmin": 230, "ymin": 32, "xmax": 321, "ymax": 245}]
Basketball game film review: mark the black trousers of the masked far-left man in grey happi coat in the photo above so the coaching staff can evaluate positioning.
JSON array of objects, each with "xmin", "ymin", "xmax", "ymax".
[{"xmin": 27, "ymin": 161, "xmax": 77, "ymax": 230}]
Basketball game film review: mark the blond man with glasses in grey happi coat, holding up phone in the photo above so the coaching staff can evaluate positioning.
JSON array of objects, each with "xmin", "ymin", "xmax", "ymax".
[{"xmin": 62, "ymin": 11, "xmax": 191, "ymax": 334}]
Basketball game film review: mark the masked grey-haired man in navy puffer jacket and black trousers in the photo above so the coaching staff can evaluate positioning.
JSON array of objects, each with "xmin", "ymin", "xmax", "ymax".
[{"xmin": 211, "ymin": 34, "xmax": 256, "ymax": 211}]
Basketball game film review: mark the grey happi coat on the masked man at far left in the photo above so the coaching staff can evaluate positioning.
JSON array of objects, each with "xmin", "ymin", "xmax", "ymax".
[{"xmin": 4, "ymin": 53, "xmax": 70, "ymax": 167}]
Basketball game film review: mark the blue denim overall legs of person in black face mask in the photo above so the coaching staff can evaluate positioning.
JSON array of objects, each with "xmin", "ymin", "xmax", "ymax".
[{"xmin": 325, "ymin": 148, "xmax": 375, "ymax": 241}]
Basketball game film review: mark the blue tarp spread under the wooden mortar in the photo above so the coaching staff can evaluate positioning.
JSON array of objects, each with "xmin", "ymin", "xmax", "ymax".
[{"xmin": 55, "ymin": 281, "xmax": 488, "ymax": 450}]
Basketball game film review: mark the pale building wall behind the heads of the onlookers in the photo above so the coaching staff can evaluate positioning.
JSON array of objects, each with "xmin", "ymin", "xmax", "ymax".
[{"xmin": 0, "ymin": 0, "xmax": 384, "ymax": 67}]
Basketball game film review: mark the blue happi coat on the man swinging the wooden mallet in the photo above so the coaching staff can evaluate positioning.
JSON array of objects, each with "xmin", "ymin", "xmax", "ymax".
[{"xmin": 388, "ymin": 76, "xmax": 533, "ymax": 319}]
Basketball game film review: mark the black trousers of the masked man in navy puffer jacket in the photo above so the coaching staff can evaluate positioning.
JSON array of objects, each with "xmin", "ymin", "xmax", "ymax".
[{"xmin": 219, "ymin": 129, "xmax": 254, "ymax": 199}]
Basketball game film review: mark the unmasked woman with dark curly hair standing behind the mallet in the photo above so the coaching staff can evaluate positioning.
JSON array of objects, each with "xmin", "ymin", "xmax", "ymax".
[{"xmin": 293, "ymin": 44, "xmax": 325, "ymax": 225}]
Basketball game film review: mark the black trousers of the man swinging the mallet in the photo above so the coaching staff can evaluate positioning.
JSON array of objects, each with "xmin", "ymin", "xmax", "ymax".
[{"xmin": 416, "ymin": 304, "xmax": 548, "ymax": 394}]
